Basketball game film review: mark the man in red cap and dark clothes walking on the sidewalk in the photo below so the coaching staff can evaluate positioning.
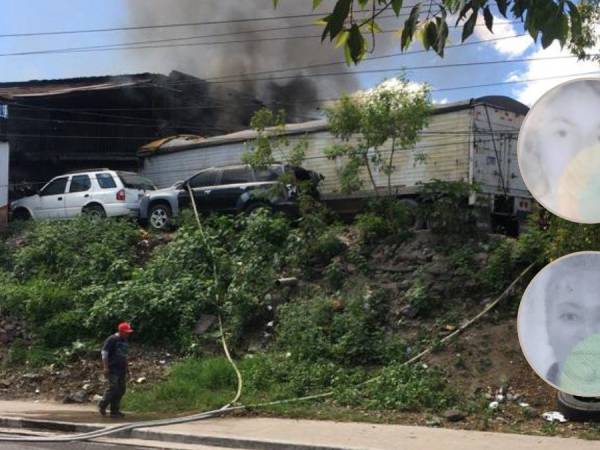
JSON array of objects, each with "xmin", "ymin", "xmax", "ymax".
[{"xmin": 98, "ymin": 322, "xmax": 133, "ymax": 417}]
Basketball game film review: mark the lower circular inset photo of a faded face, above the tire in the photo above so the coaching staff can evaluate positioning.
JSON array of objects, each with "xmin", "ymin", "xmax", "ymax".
[{"xmin": 517, "ymin": 252, "xmax": 600, "ymax": 397}]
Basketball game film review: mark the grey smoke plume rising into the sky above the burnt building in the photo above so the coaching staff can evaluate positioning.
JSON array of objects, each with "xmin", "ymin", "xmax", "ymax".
[{"xmin": 123, "ymin": 0, "xmax": 358, "ymax": 121}]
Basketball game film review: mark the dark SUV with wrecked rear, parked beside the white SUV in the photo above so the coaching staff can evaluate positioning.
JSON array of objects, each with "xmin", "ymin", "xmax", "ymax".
[{"xmin": 140, "ymin": 164, "xmax": 323, "ymax": 230}]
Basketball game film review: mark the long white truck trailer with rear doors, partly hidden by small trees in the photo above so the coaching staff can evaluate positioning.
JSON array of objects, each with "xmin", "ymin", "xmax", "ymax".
[{"xmin": 138, "ymin": 97, "xmax": 532, "ymax": 234}]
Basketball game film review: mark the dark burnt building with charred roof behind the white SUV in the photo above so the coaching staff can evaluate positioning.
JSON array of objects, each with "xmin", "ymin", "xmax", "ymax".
[{"xmin": 0, "ymin": 71, "xmax": 262, "ymax": 197}]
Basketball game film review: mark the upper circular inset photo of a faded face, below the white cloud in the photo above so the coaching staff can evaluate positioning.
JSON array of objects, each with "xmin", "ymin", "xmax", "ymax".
[{"xmin": 517, "ymin": 78, "xmax": 600, "ymax": 223}]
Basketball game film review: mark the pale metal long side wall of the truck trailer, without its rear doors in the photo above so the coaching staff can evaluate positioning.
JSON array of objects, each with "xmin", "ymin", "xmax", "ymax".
[{"xmin": 143, "ymin": 109, "xmax": 472, "ymax": 197}]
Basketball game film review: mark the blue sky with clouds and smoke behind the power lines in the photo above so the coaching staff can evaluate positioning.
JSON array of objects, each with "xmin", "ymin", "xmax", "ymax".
[{"xmin": 0, "ymin": 0, "xmax": 600, "ymax": 109}]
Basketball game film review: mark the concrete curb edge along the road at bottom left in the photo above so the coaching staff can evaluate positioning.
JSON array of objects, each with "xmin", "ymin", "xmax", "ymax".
[{"xmin": 0, "ymin": 417, "xmax": 356, "ymax": 450}]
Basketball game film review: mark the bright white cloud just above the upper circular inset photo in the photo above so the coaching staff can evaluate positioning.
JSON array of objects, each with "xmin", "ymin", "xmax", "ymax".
[{"xmin": 507, "ymin": 34, "xmax": 600, "ymax": 106}]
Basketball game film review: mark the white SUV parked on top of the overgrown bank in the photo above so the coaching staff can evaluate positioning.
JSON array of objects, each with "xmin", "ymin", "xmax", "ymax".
[{"xmin": 10, "ymin": 169, "xmax": 156, "ymax": 219}]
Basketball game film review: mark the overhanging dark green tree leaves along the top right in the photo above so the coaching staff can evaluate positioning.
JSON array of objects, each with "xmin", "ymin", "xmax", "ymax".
[{"xmin": 280, "ymin": 0, "xmax": 599, "ymax": 64}]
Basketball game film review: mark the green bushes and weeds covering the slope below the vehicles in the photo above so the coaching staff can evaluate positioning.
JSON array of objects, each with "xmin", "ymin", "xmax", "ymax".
[{"xmin": 5, "ymin": 185, "xmax": 600, "ymax": 417}]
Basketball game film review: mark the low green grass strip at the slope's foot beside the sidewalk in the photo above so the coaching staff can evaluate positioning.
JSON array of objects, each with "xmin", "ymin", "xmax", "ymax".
[{"xmin": 124, "ymin": 355, "xmax": 453, "ymax": 421}]
